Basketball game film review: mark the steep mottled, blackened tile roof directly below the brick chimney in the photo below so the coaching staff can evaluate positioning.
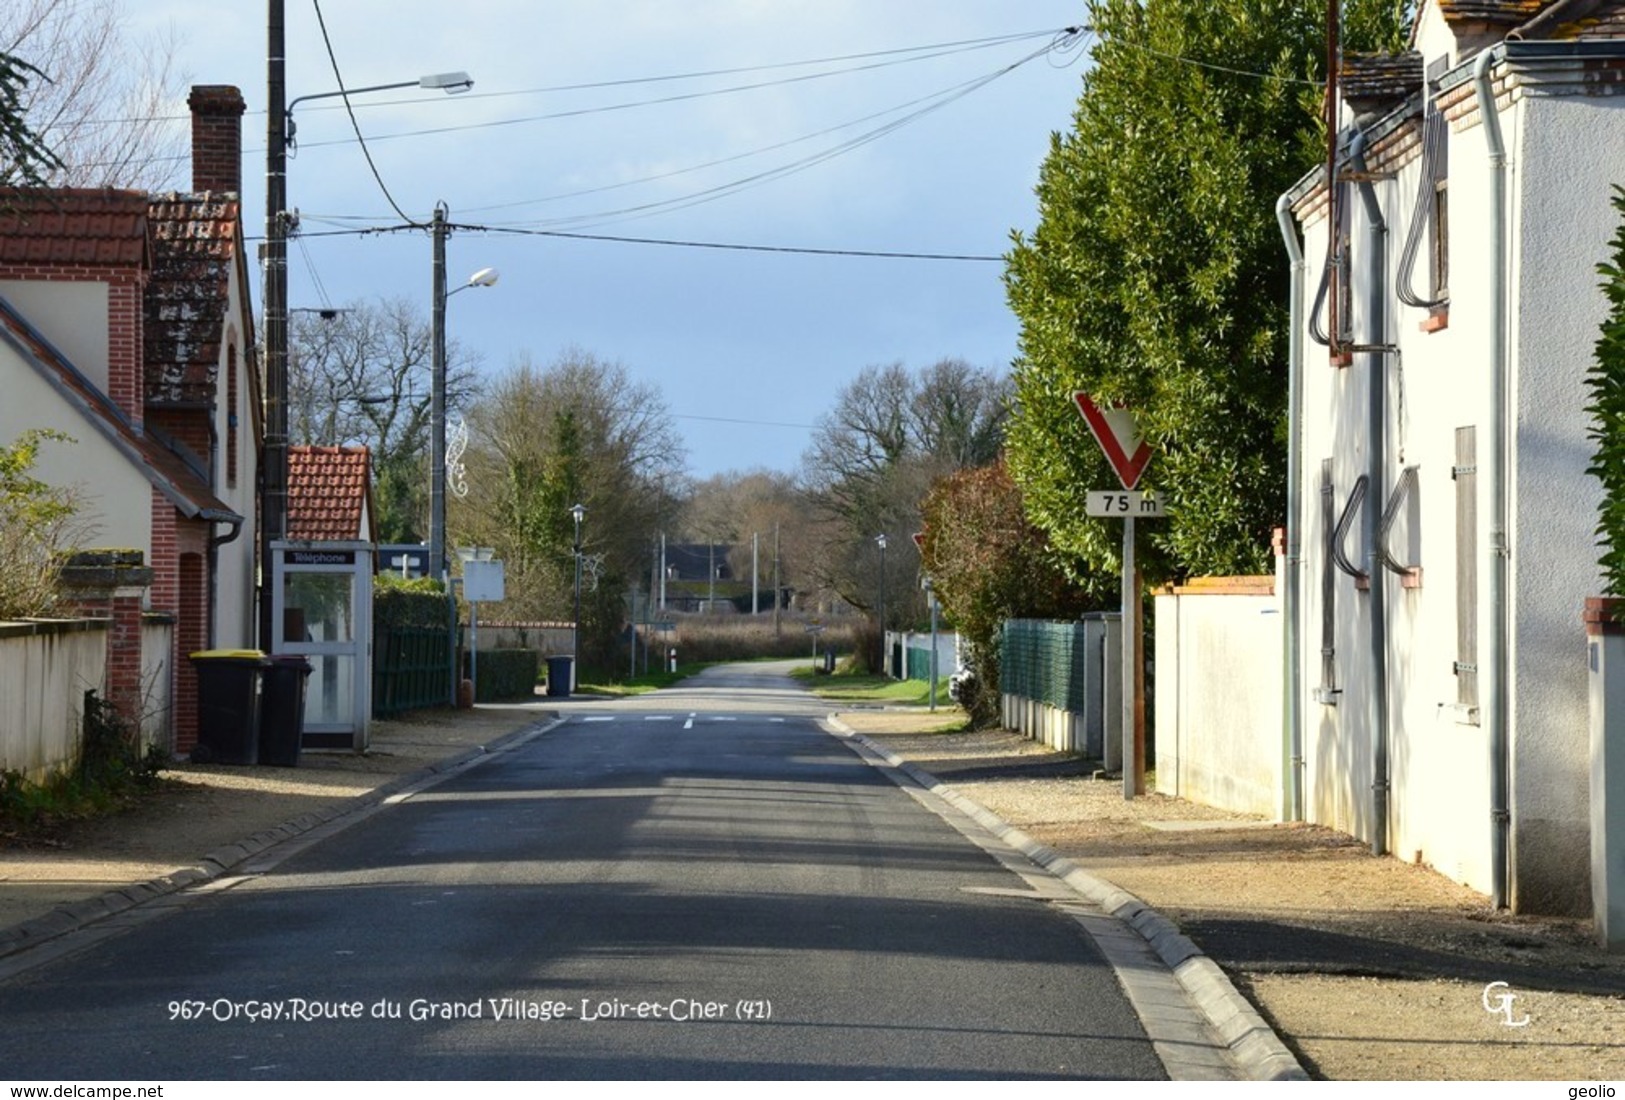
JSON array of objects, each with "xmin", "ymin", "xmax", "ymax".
[{"xmin": 143, "ymin": 192, "xmax": 241, "ymax": 403}]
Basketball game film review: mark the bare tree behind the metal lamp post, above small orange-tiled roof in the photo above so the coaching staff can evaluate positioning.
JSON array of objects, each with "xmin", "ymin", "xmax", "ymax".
[{"xmin": 288, "ymin": 297, "xmax": 479, "ymax": 543}]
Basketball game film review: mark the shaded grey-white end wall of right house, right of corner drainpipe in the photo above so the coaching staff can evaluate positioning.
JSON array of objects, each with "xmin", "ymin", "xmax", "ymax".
[{"xmin": 1508, "ymin": 88, "xmax": 1625, "ymax": 910}]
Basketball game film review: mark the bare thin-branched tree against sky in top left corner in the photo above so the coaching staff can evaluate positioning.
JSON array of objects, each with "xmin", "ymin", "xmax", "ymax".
[{"xmin": 0, "ymin": 0, "xmax": 187, "ymax": 190}]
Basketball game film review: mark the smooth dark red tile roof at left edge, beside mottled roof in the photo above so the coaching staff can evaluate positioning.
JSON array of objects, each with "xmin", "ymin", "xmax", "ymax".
[{"xmin": 0, "ymin": 188, "xmax": 146, "ymax": 266}]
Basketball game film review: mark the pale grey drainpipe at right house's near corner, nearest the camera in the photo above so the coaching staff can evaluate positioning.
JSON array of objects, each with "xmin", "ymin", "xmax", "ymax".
[{"xmin": 1472, "ymin": 50, "xmax": 1511, "ymax": 908}]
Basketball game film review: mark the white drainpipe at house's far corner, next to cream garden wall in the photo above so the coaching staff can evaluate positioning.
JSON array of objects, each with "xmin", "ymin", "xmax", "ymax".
[{"xmin": 1276, "ymin": 195, "xmax": 1305, "ymax": 821}]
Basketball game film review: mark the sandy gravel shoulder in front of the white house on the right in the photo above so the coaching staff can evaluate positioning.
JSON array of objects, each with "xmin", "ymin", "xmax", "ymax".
[{"xmin": 842, "ymin": 710, "xmax": 1625, "ymax": 1082}]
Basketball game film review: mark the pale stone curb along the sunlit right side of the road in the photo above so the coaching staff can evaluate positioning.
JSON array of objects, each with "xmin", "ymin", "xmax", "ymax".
[{"xmin": 827, "ymin": 715, "xmax": 1310, "ymax": 1081}]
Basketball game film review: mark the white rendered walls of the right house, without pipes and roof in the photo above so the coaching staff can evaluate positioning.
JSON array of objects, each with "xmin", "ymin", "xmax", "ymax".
[{"xmin": 1300, "ymin": 53, "xmax": 1625, "ymax": 912}]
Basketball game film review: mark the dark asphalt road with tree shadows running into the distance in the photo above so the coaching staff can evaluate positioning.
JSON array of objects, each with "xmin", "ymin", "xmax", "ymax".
[{"xmin": 0, "ymin": 668, "xmax": 1164, "ymax": 1082}]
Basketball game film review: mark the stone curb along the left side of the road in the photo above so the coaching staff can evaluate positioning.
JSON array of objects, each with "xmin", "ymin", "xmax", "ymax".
[{"xmin": 0, "ymin": 715, "xmax": 559, "ymax": 959}]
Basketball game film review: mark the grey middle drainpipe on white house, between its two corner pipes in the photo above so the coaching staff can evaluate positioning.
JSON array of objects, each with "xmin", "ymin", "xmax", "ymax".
[{"xmin": 1349, "ymin": 130, "xmax": 1389, "ymax": 856}]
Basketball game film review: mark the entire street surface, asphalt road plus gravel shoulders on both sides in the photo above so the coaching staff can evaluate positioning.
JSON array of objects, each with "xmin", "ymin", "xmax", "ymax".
[{"xmin": 0, "ymin": 665, "xmax": 1625, "ymax": 1079}]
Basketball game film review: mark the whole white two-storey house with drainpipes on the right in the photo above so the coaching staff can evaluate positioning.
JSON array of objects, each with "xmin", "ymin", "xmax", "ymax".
[{"xmin": 1285, "ymin": 0, "xmax": 1625, "ymax": 913}]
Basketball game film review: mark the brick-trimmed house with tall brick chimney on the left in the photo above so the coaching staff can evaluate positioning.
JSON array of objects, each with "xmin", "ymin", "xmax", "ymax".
[{"xmin": 0, "ymin": 86, "xmax": 260, "ymax": 752}]
